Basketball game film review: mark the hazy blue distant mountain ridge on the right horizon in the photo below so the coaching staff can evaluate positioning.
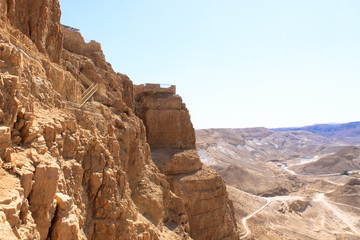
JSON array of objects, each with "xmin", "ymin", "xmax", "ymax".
[{"xmin": 272, "ymin": 122, "xmax": 360, "ymax": 144}]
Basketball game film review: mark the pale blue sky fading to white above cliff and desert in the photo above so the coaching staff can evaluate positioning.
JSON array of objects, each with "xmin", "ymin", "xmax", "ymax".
[{"xmin": 60, "ymin": 0, "xmax": 360, "ymax": 129}]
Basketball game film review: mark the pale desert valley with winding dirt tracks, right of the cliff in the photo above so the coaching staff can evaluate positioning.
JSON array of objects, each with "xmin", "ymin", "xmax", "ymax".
[{"xmin": 196, "ymin": 124, "xmax": 360, "ymax": 240}]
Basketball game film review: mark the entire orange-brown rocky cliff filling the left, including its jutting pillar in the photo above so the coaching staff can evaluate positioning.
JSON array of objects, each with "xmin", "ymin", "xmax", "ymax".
[{"xmin": 0, "ymin": 0, "xmax": 236, "ymax": 240}]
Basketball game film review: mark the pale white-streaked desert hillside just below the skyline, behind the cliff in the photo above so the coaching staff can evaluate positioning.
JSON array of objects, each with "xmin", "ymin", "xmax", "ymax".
[{"xmin": 196, "ymin": 128, "xmax": 344, "ymax": 167}]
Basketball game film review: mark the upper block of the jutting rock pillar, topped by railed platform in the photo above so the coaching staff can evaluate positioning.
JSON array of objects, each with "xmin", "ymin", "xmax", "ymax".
[{"xmin": 134, "ymin": 84, "xmax": 195, "ymax": 149}]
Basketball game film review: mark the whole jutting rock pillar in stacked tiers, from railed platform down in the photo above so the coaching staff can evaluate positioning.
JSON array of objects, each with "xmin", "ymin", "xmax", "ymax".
[{"xmin": 135, "ymin": 84, "xmax": 238, "ymax": 240}]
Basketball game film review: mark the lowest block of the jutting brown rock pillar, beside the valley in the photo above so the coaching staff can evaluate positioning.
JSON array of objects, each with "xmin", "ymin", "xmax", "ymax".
[{"xmin": 169, "ymin": 166, "xmax": 238, "ymax": 240}]
